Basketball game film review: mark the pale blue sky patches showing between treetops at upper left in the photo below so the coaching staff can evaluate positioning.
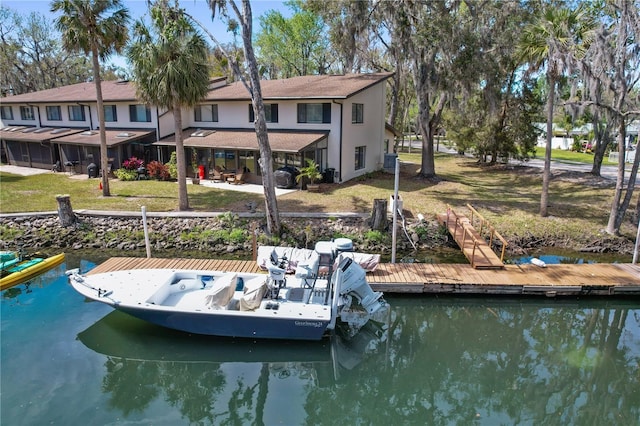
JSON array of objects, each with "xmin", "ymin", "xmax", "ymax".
[{"xmin": 0, "ymin": 0, "xmax": 290, "ymax": 68}]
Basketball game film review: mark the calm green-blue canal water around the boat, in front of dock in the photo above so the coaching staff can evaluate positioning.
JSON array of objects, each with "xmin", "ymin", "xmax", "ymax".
[{"xmin": 0, "ymin": 255, "xmax": 640, "ymax": 426}]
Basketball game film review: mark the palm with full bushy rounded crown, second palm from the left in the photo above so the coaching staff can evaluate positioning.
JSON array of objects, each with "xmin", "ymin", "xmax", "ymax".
[{"xmin": 127, "ymin": 0, "xmax": 210, "ymax": 210}]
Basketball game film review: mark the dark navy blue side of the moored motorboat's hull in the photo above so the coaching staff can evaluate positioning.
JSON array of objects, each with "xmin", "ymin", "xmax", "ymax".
[{"xmin": 114, "ymin": 305, "xmax": 329, "ymax": 340}]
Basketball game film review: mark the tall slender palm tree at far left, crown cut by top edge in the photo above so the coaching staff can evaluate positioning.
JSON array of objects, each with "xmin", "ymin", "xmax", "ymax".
[{"xmin": 51, "ymin": 0, "xmax": 130, "ymax": 197}]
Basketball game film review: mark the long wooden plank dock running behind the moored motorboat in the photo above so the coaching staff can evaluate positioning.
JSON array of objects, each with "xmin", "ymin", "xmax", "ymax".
[{"xmin": 90, "ymin": 257, "xmax": 640, "ymax": 297}]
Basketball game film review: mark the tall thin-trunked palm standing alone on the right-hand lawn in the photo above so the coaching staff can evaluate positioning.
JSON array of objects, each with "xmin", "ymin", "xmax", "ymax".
[{"xmin": 519, "ymin": 4, "xmax": 592, "ymax": 217}]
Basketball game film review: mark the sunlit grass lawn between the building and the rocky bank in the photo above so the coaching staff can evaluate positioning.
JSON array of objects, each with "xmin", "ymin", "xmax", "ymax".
[{"xmin": 0, "ymin": 154, "xmax": 636, "ymax": 250}]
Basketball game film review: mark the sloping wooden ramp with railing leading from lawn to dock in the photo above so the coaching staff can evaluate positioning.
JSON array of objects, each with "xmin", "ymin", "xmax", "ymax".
[{"xmin": 438, "ymin": 208, "xmax": 504, "ymax": 269}]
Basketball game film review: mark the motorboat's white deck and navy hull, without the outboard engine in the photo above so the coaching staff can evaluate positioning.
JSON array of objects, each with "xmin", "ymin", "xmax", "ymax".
[{"xmin": 68, "ymin": 269, "xmax": 332, "ymax": 340}]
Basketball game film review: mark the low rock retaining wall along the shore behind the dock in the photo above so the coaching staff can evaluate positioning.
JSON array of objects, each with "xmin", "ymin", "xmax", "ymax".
[{"xmin": 0, "ymin": 214, "xmax": 448, "ymax": 255}]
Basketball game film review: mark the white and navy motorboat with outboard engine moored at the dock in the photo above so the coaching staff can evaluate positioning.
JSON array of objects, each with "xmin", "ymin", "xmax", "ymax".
[{"xmin": 67, "ymin": 239, "xmax": 389, "ymax": 340}]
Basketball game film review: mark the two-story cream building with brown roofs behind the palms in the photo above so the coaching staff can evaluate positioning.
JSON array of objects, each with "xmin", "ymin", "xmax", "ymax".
[{"xmin": 0, "ymin": 73, "xmax": 393, "ymax": 183}]
